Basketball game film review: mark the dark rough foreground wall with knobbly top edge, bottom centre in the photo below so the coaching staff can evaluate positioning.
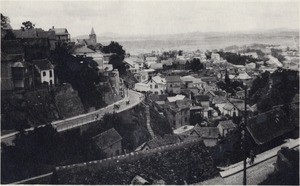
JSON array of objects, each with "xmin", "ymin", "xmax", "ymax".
[{"xmin": 53, "ymin": 140, "xmax": 218, "ymax": 184}]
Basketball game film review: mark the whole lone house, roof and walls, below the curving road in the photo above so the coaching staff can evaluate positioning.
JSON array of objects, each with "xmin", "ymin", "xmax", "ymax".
[{"xmin": 92, "ymin": 128, "xmax": 122, "ymax": 157}]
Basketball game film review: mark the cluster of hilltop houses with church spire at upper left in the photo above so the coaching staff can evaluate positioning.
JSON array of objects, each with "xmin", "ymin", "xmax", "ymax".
[{"xmin": 1, "ymin": 19, "xmax": 124, "ymax": 104}]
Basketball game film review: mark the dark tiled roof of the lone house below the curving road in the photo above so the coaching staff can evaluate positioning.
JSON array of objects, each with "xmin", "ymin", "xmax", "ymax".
[{"xmin": 93, "ymin": 128, "xmax": 122, "ymax": 149}]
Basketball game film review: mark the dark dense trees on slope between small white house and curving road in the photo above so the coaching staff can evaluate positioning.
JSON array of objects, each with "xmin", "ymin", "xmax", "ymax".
[{"xmin": 52, "ymin": 47, "xmax": 107, "ymax": 110}]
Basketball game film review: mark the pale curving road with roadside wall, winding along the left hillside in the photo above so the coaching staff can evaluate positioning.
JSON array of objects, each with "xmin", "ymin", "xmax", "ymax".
[{"xmin": 1, "ymin": 90, "xmax": 144, "ymax": 145}]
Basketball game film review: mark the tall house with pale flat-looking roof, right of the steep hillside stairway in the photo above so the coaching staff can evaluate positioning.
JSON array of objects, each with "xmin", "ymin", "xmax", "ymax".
[{"xmin": 166, "ymin": 95, "xmax": 191, "ymax": 129}]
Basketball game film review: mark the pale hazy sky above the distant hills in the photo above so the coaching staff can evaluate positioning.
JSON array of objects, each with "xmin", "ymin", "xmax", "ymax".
[{"xmin": 0, "ymin": 0, "xmax": 299, "ymax": 36}]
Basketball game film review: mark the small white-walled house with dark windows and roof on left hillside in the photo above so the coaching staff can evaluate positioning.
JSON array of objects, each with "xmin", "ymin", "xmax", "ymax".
[{"xmin": 32, "ymin": 59, "xmax": 55, "ymax": 86}]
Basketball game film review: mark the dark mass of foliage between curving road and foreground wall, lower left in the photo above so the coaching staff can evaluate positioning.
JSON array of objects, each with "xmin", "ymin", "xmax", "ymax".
[{"xmin": 1, "ymin": 125, "xmax": 101, "ymax": 183}]
